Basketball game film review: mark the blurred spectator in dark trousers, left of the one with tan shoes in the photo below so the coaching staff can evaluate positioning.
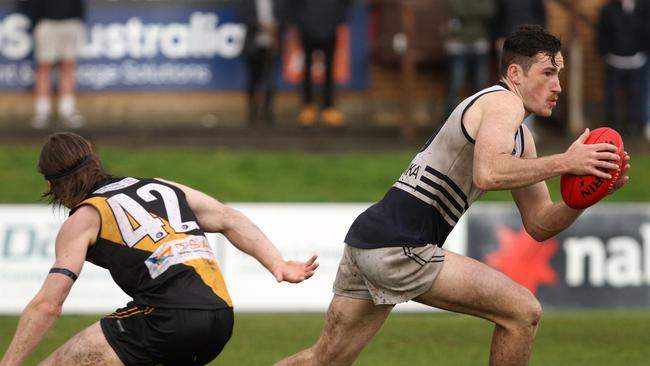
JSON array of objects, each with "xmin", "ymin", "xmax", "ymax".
[{"xmin": 240, "ymin": 0, "xmax": 286, "ymax": 125}]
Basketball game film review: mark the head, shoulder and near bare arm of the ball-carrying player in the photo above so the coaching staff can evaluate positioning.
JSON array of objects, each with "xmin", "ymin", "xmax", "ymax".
[{"xmin": 465, "ymin": 52, "xmax": 619, "ymax": 190}]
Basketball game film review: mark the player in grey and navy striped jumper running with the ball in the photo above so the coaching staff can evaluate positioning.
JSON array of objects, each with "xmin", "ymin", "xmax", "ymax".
[{"xmin": 278, "ymin": 25, "xmax": 629, "ymax": 366}]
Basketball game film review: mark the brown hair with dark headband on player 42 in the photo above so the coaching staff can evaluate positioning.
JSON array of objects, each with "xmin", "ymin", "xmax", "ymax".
[{"xmin": 38, "ymin": 132, "xmax": 108, "ymax": 208}]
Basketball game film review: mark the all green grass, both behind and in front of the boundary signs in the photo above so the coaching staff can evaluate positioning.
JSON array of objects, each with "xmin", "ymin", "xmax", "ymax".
[{"xmin": 0, "ymin": 145, "xmax": 650, "ymax": 366}]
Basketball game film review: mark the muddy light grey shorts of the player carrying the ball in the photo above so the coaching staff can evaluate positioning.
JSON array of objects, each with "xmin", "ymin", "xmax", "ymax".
[{"xmin": 333, "ymin": 244, "xmax": 445, "ymax": 305}]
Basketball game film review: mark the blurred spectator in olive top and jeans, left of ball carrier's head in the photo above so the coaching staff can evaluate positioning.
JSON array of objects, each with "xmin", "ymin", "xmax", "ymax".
[{"xmin": 445, "ymin": 0, "xmax": 496, "ymax": 118}]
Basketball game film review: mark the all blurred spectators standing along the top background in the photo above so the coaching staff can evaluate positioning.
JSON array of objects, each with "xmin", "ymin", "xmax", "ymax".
[{"xmin": 12, "ymin": 0, "xmax": 650, "ymax": 140}]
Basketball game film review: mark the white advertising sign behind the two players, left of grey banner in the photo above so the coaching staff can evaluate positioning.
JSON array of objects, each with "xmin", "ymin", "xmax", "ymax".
[{"xmin": 0, "ymin": 203, "xmax": 466, "ymax": 314}]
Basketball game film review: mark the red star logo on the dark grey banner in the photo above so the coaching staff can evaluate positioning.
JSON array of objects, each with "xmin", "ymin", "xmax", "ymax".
[{"xmin": 485, "ymin": 226, "xmax": 560, "ymax": 294}]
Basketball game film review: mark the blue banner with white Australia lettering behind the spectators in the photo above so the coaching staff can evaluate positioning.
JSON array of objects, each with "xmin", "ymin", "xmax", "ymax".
[{"xmin": 0, "ymin": 0, "xmax": 368, "ymax": 91}]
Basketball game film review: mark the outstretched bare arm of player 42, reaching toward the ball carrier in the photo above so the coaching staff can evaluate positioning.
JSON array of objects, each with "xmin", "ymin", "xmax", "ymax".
[{"xmin": 159, "ymin": 181, "xmax": 318, "ymax": 283}]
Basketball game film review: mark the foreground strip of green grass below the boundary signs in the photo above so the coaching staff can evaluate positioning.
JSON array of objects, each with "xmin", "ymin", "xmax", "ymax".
[{"xmin": 0, "ymin": 311, "xmax": 650, "ymax": 366}]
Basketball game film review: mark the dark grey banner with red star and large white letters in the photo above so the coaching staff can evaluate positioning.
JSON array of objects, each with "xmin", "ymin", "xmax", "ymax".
[{"xmin": 467, "ymin": 204, "xmax": 650, "ymax": 308}]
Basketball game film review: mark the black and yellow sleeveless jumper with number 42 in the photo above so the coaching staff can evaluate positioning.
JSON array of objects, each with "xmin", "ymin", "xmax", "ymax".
[{"xmin": 80, "ymin": 178, "xmax": 232, "ymax": 308}]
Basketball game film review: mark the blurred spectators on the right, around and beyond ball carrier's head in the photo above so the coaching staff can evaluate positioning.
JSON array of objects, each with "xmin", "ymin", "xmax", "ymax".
[{"xmin": 445, "ymin": 0, "xmax": 650, "ymax": 141}]
